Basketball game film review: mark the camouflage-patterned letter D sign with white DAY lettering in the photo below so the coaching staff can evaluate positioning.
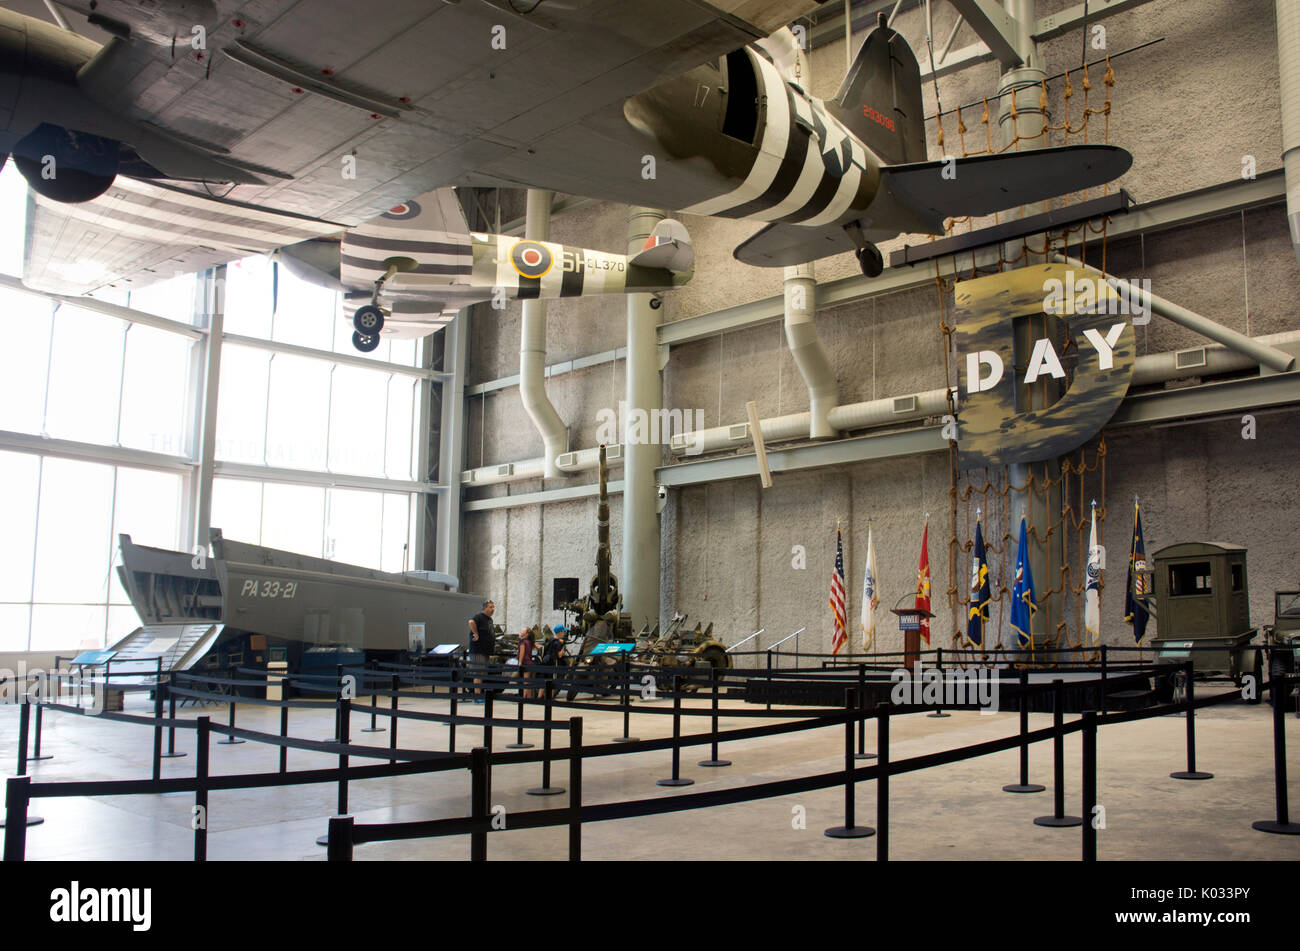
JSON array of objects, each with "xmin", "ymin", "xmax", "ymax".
[{"xmin": 954, "ymin": 264, "xmax": 1135, "ymax": 469}]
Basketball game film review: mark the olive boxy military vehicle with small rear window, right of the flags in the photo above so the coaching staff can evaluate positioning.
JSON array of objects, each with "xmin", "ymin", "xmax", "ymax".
[{"xmin": 1152, "ymin": 542, "xmax": 1264, "ymax": 702}]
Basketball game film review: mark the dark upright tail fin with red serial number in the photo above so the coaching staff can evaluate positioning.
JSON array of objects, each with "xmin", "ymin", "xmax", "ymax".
[{"xmin": 827, "ymin": 14, "xmax": 927, "ymax": 165}]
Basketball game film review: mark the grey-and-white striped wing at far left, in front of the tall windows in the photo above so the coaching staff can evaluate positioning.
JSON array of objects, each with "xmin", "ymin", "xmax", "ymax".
[{"xmin": 22, "ymin": 175, "xmax": 343, "ymax": 296}]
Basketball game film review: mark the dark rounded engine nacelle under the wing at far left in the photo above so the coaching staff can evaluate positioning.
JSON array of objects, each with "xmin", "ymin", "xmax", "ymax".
[{"xmin": 13, "ymin": 122, "xmax": 120, "ymax": 203}]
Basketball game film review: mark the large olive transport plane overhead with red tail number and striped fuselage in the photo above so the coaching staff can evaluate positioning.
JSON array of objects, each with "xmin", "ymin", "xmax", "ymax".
[{"xmin": 0, "ymin": 0, "xmax": 1131, "ymax": 274}]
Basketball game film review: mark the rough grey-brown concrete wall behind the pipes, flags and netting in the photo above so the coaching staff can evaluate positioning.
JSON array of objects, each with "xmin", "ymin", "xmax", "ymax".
[{"xmin": 463, "ymin": 0, "xmax": 1300, "ymax": 651}]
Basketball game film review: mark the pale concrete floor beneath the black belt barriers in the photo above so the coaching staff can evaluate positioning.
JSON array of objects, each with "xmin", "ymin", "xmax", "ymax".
[{"xmin": 0, "ymin": 696, "xmax": 1300, "ymax": 861}]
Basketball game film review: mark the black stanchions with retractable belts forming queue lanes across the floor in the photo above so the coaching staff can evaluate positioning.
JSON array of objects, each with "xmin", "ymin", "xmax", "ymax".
[{"xmin": 4, "ymin": 661, "xmax": 1300, "ymax": 860}]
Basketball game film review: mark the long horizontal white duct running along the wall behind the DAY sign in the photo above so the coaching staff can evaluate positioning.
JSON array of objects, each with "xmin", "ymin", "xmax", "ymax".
[{"xmin": 463, "ymin": 330, "xmax": 1300, "ymax": 486}]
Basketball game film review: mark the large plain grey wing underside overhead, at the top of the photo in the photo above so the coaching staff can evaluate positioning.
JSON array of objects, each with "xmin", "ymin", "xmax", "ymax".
[{"xmin": 55, "ymin": 0, "xmax": 824, "ymax": 225}]
